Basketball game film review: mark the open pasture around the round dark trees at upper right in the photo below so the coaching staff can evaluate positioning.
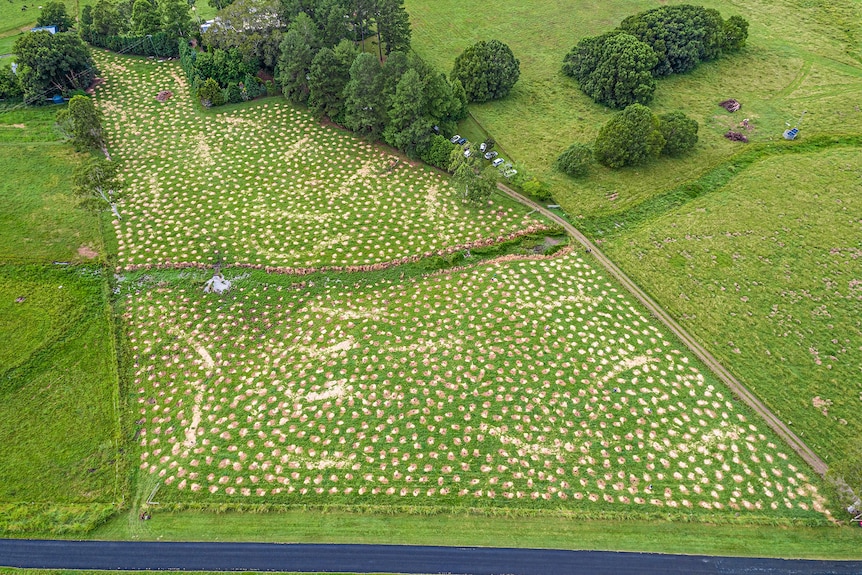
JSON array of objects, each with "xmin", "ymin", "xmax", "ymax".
[{"xmin": 406, "ymin": 0, "xmax": 862, "ymax": 217}]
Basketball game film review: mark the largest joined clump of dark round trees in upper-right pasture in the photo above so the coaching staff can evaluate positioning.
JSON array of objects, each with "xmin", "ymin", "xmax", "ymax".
[{"xmin": 563, "ymin": 4, "xmax": 748, "ymax": 108}]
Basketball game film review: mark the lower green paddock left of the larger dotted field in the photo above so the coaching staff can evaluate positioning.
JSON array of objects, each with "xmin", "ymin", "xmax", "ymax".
[{"xmin": 0, "ymin": 265, "xmax": 123, "ymax": 533}]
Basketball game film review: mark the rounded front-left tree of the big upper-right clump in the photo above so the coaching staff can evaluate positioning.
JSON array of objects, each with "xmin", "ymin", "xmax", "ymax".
[{"xmin": 563, "ymin": 32, "xmax": 658, "ymax": 108}]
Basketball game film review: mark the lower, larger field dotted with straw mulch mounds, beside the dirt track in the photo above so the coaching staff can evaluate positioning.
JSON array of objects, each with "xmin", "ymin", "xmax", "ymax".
[{"xmin": 125, "ymin": 255, "xmax": 832, "ymax": 521}]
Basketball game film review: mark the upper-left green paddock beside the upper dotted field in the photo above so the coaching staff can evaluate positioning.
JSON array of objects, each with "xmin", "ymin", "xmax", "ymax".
[{"xmin": 0, "ymin": 106, "xmax": 103, "ymax": 263}]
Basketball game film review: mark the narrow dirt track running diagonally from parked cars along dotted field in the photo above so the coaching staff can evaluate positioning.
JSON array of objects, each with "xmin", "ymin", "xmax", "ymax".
[{"xmin": 497, "ymin": 184, "xmax": 827, "ymax": 475}]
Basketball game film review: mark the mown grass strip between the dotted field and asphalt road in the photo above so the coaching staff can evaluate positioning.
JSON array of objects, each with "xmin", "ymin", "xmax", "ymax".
[{"xmin": 91, "ymin": 509, "xmax": 862, "ymax": 559}]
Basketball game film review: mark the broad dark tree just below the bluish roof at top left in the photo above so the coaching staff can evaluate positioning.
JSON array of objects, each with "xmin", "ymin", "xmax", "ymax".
[{"xmin": 14, "ymin": 32, "xmax": 96, "ymax": 103}]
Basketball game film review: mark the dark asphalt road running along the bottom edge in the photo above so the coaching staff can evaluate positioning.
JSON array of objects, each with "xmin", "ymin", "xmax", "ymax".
[{"xmin": 0, "ymin": 539, "xmax": 862, "ymax": 575}]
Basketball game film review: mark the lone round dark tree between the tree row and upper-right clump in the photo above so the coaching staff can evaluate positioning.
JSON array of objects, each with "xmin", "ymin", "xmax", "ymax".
[{"xmin": 450, "ymin": 40, "xmax": 521, "ymax": 102}]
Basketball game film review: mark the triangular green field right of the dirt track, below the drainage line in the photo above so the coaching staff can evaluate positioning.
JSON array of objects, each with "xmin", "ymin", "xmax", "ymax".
[{"xmin": 605, "ymin": 147, "xmax": 862, "ymax": 461}]
